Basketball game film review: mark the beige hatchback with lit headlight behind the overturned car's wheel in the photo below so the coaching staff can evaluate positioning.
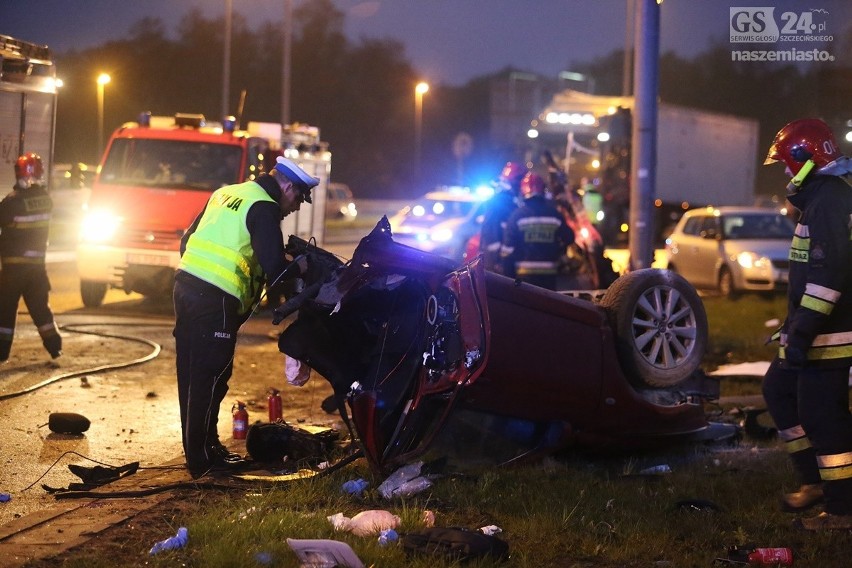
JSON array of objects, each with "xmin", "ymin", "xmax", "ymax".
[{"xmin": 666, "ymin": 207, "xmax": 796, "ymax": 297}]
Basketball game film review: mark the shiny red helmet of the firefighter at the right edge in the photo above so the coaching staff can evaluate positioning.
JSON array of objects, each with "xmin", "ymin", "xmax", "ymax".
[{"xmin": 763, "ymin": 118, "xmax": 840, "ymax": 175}]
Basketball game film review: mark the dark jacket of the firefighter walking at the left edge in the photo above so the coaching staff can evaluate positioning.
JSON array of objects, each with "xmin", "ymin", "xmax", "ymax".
[{"xmin": 0, "ymin": 185, "xmax": 53, "ymax": 265}]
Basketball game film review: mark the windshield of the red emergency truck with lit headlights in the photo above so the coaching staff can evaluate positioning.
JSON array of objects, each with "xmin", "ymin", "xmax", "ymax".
[{"xmin": 100, "ymin": 138, "xmax": 242, "ymax": 191}]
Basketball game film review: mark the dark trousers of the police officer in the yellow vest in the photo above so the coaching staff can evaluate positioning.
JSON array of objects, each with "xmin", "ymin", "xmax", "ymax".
[{"xmin": 174, "ymin": 272, "xmax": 247, "ymax": 473}]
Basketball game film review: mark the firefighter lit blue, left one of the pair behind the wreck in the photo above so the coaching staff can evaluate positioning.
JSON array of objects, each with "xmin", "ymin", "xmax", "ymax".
[{"xmin": 479, "ymin": 162, "xmax": 527, "ymax": 272}]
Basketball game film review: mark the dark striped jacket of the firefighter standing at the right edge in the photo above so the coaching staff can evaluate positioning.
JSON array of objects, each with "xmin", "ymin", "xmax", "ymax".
[{"xmin": 779, "ymin": 159, "xmax": 852, "ymax": 367}]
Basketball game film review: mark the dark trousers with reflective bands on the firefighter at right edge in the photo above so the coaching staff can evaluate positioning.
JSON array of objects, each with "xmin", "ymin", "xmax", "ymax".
[{"xmin": 763, "ymin": 358, "xmax": 852, "ymax": 515}]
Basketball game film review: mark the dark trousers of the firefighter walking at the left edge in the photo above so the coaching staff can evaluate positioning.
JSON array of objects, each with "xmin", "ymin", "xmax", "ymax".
[{"xmin": 0, "ymin": 262, "xmax": 62, "ymax": 361}]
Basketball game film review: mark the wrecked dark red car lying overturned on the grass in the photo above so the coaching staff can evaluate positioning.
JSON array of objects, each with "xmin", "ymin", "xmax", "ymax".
[{"xmin": 274, "ymin": 218, "xmax": 735, "ymax": 472}]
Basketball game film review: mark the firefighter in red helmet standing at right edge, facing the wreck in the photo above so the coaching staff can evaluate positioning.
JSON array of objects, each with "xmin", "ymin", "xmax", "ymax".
[{"xmin": 763, "ymin": 119, "xmax": 852, "ymax": 530}]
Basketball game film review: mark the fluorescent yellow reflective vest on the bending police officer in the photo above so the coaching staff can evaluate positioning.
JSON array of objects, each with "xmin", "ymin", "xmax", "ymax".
[{"xmin": 178, "ymin": 181, "xmax": 280, "ymax": 313}]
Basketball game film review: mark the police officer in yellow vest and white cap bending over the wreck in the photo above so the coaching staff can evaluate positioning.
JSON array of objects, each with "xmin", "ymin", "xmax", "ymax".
[{"xmin": 174, "ymin": 157, "xmax": 319, "ymax": 478}]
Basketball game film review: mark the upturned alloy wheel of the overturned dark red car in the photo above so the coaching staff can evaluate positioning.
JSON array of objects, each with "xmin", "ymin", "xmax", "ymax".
[{"xmin": 600, "ymin": 268, "xmax": 708, "ymax": 387}]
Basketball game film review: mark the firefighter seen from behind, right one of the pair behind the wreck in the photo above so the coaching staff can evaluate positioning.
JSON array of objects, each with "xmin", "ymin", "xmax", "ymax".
[{"xmin": 500, "ymin": 172, "xmax": 574, "ymax": 290}]
